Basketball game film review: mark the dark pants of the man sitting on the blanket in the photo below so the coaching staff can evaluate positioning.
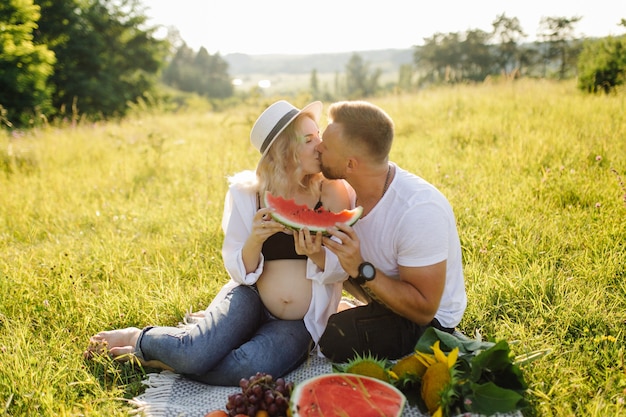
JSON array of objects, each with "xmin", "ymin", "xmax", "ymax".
[{"xmin": 319, "ymin": 302, "xmax": 454, "ymax": 363}]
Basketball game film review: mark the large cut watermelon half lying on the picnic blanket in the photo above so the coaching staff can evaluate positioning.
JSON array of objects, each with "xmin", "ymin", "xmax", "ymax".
[{"xmin": 290, "ymin": 373, "xmax": 406, "ymax": 417}]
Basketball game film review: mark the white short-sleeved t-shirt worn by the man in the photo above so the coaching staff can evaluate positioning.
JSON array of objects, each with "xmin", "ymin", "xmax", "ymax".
[{"xmin": 354, "ymin": 165, "xmax": 467, "ymax": 328}]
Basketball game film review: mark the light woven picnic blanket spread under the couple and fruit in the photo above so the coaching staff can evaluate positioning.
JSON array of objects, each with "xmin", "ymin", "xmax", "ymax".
[{"xmin": 130, "ymin": 356, "xmax": 522, "ymax": 417}]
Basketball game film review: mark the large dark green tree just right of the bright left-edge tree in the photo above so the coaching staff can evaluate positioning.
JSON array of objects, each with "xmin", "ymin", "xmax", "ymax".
[{"xmin": 36, "ymin": 0, "xmax": 167, "ymax": 118}]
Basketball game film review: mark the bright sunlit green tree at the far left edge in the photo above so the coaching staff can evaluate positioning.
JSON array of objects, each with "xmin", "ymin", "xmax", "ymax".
[{"xmin": 0, "ymin": 0, "xmax": 55, "ymax": 125}]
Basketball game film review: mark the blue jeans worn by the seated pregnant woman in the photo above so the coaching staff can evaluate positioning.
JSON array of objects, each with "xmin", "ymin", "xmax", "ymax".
[{"xmin": 135, "ymin": 285, "xmax": 313, "ymax": 386}]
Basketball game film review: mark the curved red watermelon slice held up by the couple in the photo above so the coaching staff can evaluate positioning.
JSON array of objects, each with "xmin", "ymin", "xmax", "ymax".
[{"xmin": 265, "ymin": 191, "xmax": 363, "ymax": 233}]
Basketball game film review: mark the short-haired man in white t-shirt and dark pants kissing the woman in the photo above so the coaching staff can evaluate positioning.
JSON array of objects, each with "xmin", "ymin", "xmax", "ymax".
[{"xmin": 317, "ymin": 101, "xmax": 467, "ymax": 362}]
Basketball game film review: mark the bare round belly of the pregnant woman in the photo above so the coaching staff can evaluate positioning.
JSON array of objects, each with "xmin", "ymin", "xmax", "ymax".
[{"xmin": 257, "ymin": 259, "xmax": 311, "ymax": 320}]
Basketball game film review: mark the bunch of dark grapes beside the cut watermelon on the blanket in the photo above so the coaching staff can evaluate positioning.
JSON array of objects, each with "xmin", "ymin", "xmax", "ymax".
[{"xmin": 226, "ymin": 372, "xmax": 293, "ymax": 417}]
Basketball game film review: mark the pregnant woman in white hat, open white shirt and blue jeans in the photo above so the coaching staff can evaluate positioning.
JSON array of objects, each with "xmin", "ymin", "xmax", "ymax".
[{"xmin": 85, "ymin": 101, "xmax": 350, "ymax": 385}]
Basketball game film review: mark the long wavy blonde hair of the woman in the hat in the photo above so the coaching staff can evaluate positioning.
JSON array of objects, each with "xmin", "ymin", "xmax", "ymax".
[{"xmin": 256, "ymin": 113, "xmax": 323, "ymax": 198}]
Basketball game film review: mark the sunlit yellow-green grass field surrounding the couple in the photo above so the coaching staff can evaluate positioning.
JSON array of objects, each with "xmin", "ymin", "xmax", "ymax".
[{"xmin": 0, "ymin": 80, "xmax": 626, "ymax": 417}]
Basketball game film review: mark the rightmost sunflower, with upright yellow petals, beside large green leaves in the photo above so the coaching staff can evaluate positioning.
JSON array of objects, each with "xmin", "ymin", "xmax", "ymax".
[{"xmin": 416, "ymin": 340, "xmax": 459, "ymax": 416}]
